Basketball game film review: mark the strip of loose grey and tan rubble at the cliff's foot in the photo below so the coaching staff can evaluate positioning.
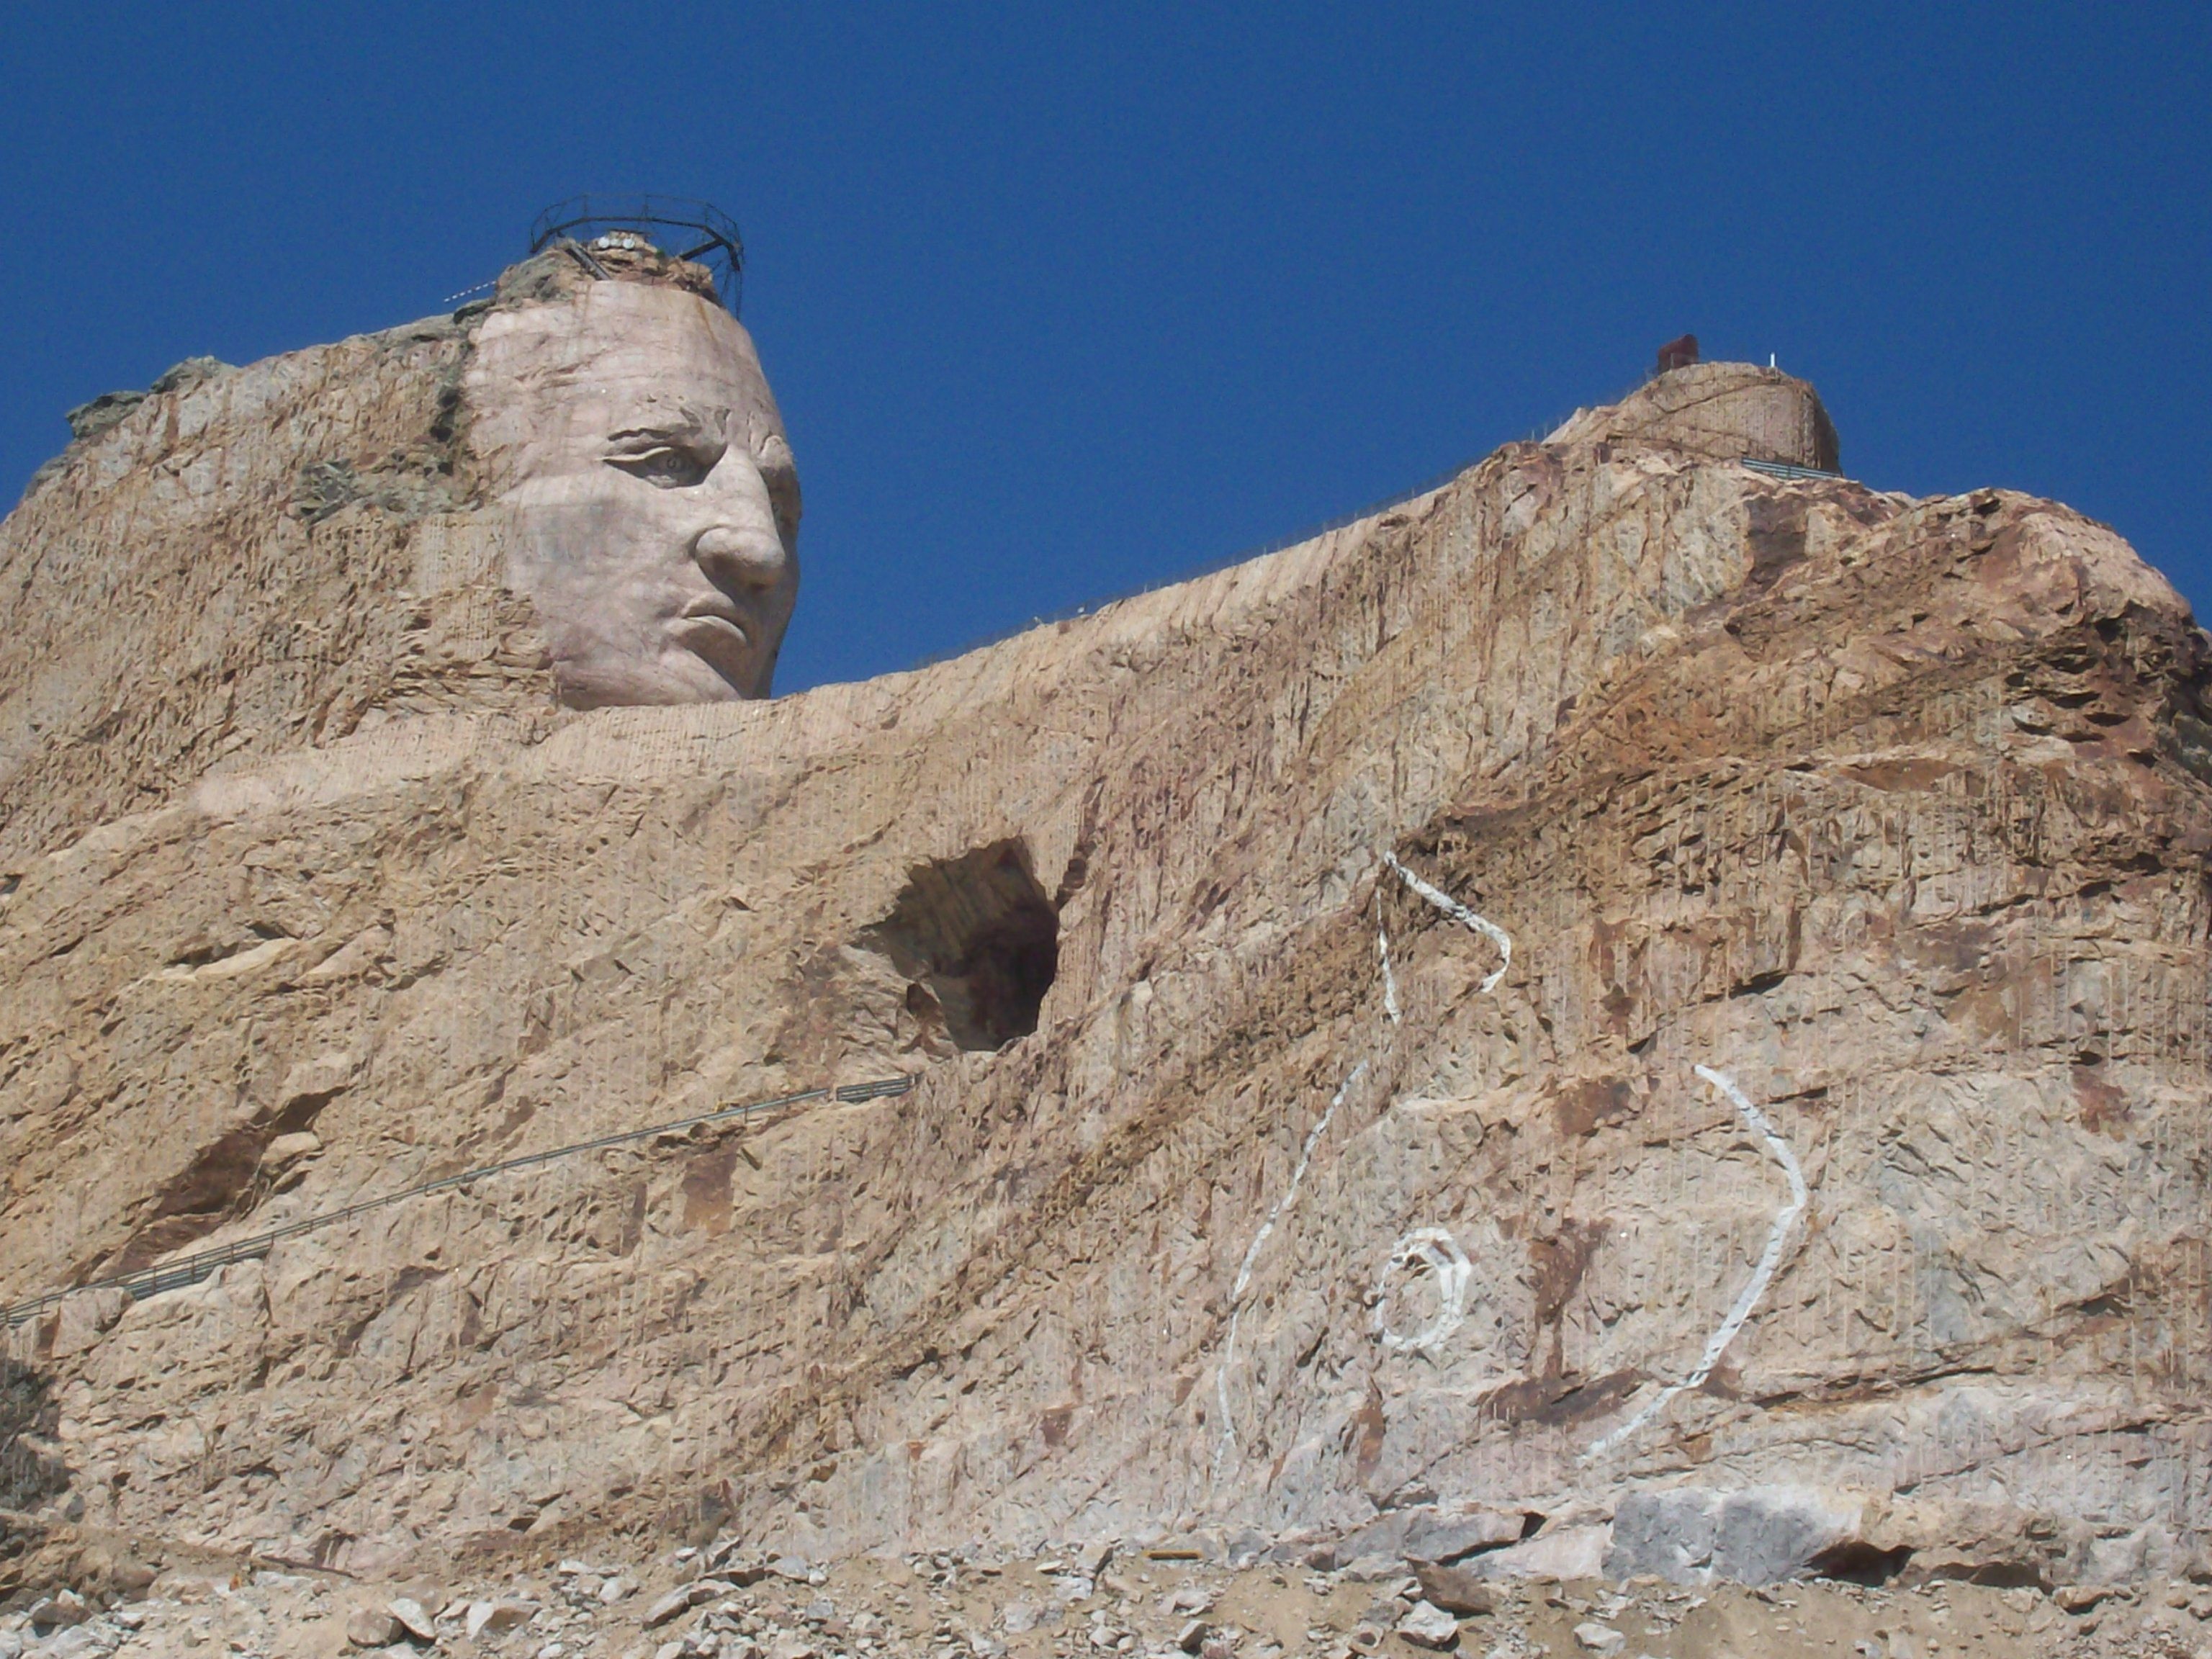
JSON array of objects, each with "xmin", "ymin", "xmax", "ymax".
[{"xmin": 0, "ymin": 1546, "xmax": 2212, "ymax": 1659}]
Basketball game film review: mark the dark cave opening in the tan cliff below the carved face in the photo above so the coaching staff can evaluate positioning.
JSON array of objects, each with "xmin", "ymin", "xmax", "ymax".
[{"xmin": 869, "ymin": 836, "xmax": 1059, "ymax": 1051}]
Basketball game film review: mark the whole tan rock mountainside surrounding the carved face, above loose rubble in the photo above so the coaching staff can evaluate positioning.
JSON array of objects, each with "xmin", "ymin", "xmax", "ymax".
[{"xmin": 0, "ymin": 325, "xmax": 2212, "ymax": 1581}]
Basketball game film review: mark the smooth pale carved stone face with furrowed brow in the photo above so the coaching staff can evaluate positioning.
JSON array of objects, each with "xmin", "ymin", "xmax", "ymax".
[{"xmin": 467, "ymin": 281, "xmax": 799, "ymax": 708}]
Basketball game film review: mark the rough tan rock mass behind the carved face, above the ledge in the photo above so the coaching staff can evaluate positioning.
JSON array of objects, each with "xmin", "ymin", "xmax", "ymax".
[{"xmin": 0, "ymin": 316, "xmax": 551, "ymax": 869}]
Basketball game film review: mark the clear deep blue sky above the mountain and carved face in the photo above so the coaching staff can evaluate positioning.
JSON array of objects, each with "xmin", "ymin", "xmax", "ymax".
[{"xmin": 0, "ymin": 0, "xmax": 2212, "ymax": 690}]
